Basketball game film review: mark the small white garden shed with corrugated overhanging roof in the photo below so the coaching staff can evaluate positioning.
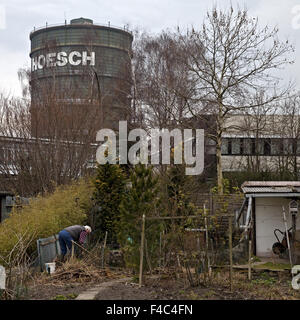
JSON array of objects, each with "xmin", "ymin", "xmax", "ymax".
[{"xmin": 240, "ymin": 181, "xmax": 300, "ymax": 257}]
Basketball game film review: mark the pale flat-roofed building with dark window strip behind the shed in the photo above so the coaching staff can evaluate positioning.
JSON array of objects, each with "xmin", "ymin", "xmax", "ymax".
[{"xmin": 221, "ymin": 114, "xmax": 300, "ymax": 177}]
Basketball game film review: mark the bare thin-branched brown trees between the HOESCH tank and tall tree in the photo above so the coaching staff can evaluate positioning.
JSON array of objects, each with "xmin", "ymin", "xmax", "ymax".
[{"xmin": 133, "ymin": 31, "xmax": 189, "ymax": 128}]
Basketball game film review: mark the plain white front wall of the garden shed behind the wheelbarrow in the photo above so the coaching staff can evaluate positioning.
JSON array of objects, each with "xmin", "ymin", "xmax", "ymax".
[{"xmin": 255, "ymin": 198, "xmax": 291, "ymax": 256}]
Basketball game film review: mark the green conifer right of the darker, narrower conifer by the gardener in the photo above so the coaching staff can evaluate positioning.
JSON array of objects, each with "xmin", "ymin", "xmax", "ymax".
[{"xmin": 118, "ymin": 164, "xmax": 162, "ymax": 270}]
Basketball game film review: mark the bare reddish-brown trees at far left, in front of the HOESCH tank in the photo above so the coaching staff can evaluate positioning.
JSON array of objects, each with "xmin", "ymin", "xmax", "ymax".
[{"xmin": 0, "ymin": 63, "xmax": 104, "ymax": 196}]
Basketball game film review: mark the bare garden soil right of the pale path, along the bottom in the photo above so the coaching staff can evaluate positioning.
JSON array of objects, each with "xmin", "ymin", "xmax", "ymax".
[{"xmin": 95, "ymin": 274, "xmax": 300, "ymax": 300}]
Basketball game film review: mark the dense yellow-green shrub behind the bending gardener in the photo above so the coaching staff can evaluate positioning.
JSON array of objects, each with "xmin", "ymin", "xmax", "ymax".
[{"xmin": 0, "ymin": 179, "xmax": 93, "ymax": 265}]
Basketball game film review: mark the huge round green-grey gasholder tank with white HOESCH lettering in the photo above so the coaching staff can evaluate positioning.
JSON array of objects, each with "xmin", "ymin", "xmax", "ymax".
[{"xmin": 30, "ymin": 18, "xmax": 133, "ymax": 138}]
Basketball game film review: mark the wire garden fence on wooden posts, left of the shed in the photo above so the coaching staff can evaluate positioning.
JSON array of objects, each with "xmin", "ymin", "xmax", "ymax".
[{"xmin": 139, "ymin": 202, "xmax": 251, "ymax": 286}]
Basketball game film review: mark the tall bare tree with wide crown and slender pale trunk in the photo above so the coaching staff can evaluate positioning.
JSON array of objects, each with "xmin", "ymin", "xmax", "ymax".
[{"xmin": 178, "ymin": 7, "xmax": 293, "ymax": 193}]
